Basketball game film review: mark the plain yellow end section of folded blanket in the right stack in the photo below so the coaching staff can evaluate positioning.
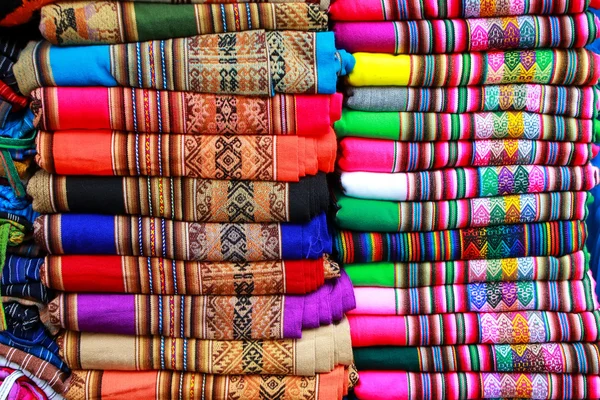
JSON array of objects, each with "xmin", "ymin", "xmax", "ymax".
[{"xmin": 348, "ymin": 53, "xmax": 410, "ymax": 86}]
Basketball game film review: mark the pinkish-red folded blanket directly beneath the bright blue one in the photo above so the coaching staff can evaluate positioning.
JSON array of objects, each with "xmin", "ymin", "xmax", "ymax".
[{"xmin": 31, "ymin": 86, "xmax": 342, "ymax": 136}]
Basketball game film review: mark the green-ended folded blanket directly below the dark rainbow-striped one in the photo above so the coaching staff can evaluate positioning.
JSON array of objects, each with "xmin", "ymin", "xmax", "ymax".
[{"xmin": 344, "ymin": 253, "xmax": 590, "ymax": 289}]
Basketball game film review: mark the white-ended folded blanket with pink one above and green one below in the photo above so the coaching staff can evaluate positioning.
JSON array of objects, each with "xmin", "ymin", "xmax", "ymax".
[{"xmin": 340, "ymin": 164, "xmax": 600, "ymax": 201}]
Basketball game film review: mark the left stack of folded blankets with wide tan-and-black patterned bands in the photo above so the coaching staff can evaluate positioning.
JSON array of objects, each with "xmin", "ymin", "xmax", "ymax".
[{"xmin": 5, "ymin": 1, "xmax": 356, "ymax": 400}]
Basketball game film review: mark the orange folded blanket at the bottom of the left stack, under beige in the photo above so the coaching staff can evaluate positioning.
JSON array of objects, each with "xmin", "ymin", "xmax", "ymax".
[{"xmin": 65, "ymin": 367, "xmax": 350, "ymax": 400}]
